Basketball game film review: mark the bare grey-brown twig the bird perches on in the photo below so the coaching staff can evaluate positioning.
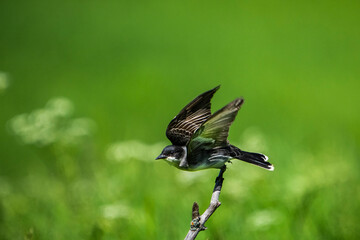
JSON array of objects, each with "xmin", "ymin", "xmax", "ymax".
[{"xmin": 185, "ymin": 166, "xmax": 226, "ymax": 240}]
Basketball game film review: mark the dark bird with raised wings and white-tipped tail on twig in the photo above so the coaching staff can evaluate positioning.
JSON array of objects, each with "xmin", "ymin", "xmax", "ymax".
[{"xmin": 156, "ymin": 86, "xmax": 274, "ymax": 171}]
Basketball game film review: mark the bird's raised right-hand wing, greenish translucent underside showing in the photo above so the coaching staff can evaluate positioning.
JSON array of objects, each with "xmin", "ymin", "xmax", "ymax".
[{"xmin": 188, "ymin": 98, "xmax": 244, "ymax": 153}]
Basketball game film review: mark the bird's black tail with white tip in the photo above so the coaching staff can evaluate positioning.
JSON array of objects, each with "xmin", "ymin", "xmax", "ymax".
[{"xmin": 231, "ymin": 146, "xmax": 274, "ymax": 171}]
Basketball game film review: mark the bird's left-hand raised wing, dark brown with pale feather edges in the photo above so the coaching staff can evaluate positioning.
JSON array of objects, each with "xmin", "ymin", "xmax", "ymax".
[{"xmin": 166, "ymin": 86, "xmax": 220, "ymax": 146}]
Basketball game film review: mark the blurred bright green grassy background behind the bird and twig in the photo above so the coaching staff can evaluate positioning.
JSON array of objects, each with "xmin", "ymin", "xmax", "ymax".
[{"xmin": 0, "ymin": 0, "xmax": 360, "ymax": 239}]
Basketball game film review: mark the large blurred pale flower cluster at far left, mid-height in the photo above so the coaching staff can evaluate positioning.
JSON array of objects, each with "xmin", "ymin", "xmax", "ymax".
[{"xmin": 9, "ymin": 98, "xmax": 95, "ymax": 147}]
